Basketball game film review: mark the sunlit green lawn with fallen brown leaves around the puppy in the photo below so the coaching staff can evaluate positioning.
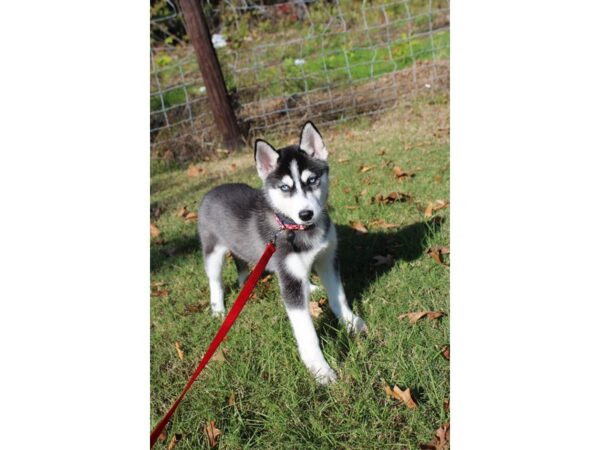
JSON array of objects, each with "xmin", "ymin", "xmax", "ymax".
[{"xmin": 150, "ymin": 96, "xmax": 449, "ymax": 449}]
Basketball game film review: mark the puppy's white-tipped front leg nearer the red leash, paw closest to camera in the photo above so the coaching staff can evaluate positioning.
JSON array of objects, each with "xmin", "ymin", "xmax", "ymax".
[{"xmin": 278, "ymin": 269, "xmax": 336, "ymax": 384}]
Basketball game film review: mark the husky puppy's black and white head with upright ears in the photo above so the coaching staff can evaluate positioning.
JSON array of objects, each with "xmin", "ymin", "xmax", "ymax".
[{"xmin": 254, "ymin": 122, "xmax": 329, "ymax": 224}]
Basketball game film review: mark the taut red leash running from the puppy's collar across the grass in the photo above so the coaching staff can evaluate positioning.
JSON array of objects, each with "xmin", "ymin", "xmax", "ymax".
[{"xmin": 150, "ymin": 240, "xmax": 275, "ymax": 448}]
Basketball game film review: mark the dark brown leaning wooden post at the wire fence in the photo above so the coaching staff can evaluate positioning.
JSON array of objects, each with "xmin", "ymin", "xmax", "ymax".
[{"xmin": 179, "ymin": 0, "xmax": 243, "ymax": 150}]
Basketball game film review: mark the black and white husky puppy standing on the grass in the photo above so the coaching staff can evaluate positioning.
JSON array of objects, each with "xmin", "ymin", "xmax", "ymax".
[{"xmin": 198, "ymin": 122, "xmax": 366, "ymax": 384}]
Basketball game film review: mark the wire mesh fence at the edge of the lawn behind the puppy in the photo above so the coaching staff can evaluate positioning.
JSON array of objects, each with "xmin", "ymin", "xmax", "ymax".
[{"xmin": 150, "ymin": 0, "xmax": 450, "ymax": 160}]
